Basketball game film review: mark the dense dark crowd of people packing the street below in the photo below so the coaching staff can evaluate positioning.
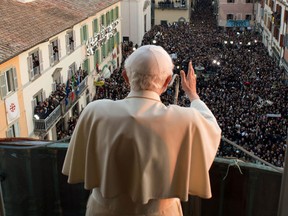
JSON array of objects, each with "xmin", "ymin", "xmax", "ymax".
[{"xmin": 91, "ymin": 1, "xmax": 288, "ymax": 167}]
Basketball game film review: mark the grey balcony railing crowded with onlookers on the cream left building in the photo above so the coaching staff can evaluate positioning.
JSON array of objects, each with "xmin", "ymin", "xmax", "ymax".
[{"xmin": 34, "ymin": 105, "xmax": 61, "ymax": 132}]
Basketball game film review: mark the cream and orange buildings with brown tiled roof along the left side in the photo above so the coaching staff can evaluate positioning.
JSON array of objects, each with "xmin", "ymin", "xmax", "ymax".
[{"xmin": 0, "ymin": 0, "xmax": 122, "ymax": 140}]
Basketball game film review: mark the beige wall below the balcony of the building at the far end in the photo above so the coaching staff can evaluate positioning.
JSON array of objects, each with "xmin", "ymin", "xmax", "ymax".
[{"xmin": 155, "ymin": 9, "xmax": 190, "ymax": 25}]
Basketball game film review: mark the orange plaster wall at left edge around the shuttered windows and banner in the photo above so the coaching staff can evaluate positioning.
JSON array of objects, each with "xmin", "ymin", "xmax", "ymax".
[{"xmin": 0, "ymin": 56, "xmax": 28, "ymax": 138}]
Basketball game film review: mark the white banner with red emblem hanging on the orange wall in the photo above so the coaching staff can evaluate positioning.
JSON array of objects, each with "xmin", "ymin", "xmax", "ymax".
[{"xmin": 5, "ymin": 93, "xmax": 20, "ymax": 124}]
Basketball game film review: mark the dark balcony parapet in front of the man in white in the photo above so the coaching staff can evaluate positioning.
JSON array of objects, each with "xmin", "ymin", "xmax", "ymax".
[{"xmin": 0, "ymin": 140, "xmax": 288, "ymax": 216}]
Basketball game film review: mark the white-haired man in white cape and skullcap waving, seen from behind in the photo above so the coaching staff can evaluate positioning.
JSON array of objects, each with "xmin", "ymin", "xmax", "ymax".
[{"xmin": 62, "ymin": 45, "xmax": 221, "ymax": 216}]
